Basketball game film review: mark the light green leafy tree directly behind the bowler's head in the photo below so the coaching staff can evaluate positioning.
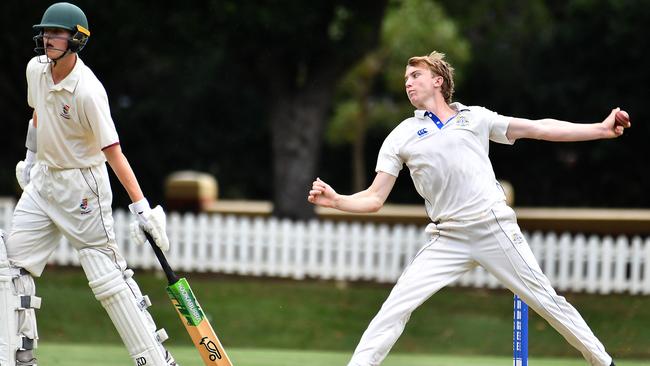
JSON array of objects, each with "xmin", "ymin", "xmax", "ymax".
[{"xmin": 327, "ymin": 0, "xmax": 469, "ymax": 192}]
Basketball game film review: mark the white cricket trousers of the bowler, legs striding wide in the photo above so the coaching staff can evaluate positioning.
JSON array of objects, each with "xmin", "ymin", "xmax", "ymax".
[{"xmin": 348, "ymin": 203, "xmax": 612, "ymax": 366}]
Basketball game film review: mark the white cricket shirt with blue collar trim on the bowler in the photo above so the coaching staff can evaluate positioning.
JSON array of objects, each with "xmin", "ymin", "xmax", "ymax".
[{"xmin": 375, "ymin": 103, "xmax": 514, "ymax": 222}]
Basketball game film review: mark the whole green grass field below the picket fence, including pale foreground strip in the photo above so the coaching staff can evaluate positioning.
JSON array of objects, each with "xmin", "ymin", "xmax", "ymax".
[{"xmin": 36, "ymin": 267, "xmax": 650, "ymax": 366}]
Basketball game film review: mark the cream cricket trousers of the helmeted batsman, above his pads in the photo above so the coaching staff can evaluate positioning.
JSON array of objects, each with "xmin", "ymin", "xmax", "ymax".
[{"xmin": 7, "ymin": 163, "xmax": 117, "ymax": 277}]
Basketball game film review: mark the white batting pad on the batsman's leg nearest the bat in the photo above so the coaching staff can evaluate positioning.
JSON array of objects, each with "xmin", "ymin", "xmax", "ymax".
[{"xmin": 79, "ymin": 249, "xmax": 168, "ymax": 366}]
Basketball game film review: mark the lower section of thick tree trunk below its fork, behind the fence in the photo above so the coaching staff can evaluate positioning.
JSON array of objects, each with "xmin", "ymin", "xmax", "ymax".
[{"xmin": 270, "ymin": 79, "xmax": 335, "ymax": 220}]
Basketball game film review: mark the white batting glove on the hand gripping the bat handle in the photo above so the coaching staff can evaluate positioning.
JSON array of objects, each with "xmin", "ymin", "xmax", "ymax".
[{"xmin": 129, "ymin": 198, "xmax": 169, "ymax": 252}]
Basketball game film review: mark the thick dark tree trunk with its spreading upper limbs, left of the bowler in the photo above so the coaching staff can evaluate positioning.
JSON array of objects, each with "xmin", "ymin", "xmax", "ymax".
[{"xmin": 261, "ymin": 0, "xmax": 387, "ymax": 220}]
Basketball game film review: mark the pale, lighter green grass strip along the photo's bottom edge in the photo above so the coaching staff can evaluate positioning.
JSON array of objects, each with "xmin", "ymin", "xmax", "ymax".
[{"xmin": 38, "ymin": 344, "xmax": 649, "ymax": 366}]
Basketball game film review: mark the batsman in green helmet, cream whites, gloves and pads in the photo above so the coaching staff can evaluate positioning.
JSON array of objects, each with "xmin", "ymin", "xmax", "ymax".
[{"xmin": 0, "ymin": 3, "xmax": 176, "ymax": 366}]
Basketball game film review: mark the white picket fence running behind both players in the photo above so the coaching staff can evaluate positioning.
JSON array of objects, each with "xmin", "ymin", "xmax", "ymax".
[{"xmin": 0, "ymin": 199, "xmax": 650, "ymax": 295}]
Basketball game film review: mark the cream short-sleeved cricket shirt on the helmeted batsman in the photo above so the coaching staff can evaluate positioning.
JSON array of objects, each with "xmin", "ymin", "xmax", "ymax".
[{"xmin": 26, "ymin": 56, "xmax": 119, "ymax": 169}]
